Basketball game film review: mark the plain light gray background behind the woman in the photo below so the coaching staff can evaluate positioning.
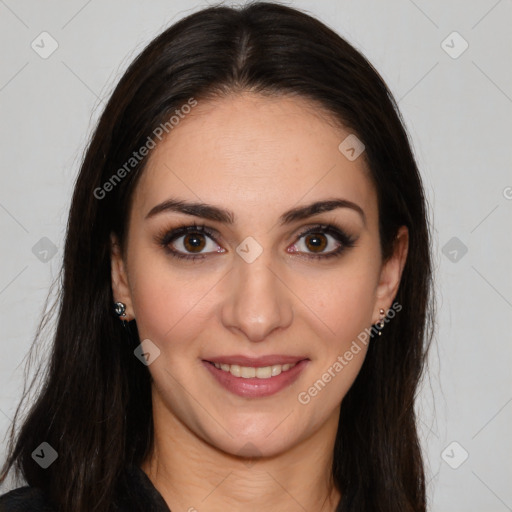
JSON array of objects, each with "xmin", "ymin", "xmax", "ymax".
[{"xmin": 0, "ymin": 0, "xmax": 512, "ymax": 512}]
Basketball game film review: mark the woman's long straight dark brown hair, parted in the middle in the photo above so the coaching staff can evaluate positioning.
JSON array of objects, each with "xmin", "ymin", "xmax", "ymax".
[{"xmin": 2, "ymin": 2, "xmax": 433, "ymax": 512}]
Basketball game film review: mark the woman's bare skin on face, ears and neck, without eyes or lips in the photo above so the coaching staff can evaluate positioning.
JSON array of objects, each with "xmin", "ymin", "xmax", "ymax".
[{"xmin": 112, "ymin": 92, "xmax": 408, "ymax": 512}]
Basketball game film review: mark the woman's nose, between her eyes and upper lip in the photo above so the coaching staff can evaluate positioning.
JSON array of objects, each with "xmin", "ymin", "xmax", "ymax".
[{"xmin": 222, "ymin": 246, "xmax": 293, "ymax": 342}]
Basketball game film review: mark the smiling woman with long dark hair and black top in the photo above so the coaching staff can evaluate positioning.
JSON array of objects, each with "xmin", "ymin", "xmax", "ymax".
[{"xmin": 0, "ymin": 3, "xmax": 431, "ymax": 512}]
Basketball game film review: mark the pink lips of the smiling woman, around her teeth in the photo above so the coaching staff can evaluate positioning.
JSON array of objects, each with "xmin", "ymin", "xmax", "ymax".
[{"xmin": 202, "ymin": 356, "xmax": 310, "ymax": 398}]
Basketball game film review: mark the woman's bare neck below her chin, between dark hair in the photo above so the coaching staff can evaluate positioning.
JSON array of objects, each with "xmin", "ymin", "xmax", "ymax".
[{"xmin": 142, "ymin": 394, "xmax": 340, "ymax": 512}]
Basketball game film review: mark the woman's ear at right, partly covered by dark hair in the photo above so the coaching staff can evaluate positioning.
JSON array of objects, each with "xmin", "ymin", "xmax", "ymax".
[{"xmin": 374, "ymin": 226, "xmax": 409, "ymax": 323}]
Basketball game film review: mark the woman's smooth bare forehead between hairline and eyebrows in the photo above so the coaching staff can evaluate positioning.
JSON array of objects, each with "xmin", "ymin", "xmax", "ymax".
[{"xmin": 133, "ymin": 93, "xmax": 376, "ymax": 224}]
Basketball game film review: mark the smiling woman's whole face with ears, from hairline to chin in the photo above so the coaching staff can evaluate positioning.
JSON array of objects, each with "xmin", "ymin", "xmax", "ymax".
[{"xmin": 112, "ymin": 93, "xmax": 407, "ymax": 456}]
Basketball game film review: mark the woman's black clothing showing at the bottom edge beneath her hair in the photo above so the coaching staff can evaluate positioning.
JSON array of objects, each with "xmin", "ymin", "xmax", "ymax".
[{"xmin": 0, "ymin": 466, "xmax": 341, "ymax": 512}]
